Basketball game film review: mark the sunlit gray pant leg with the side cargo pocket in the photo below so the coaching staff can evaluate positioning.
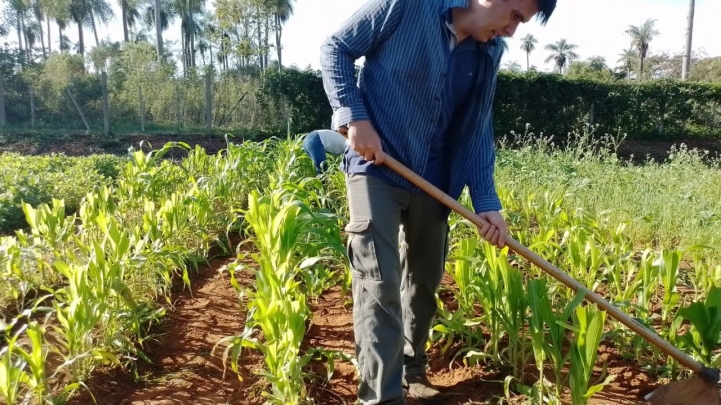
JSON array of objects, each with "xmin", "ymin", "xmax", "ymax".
[{"xmin": 346, "ymin": 174, "xmax": 410, "ymax": 405}]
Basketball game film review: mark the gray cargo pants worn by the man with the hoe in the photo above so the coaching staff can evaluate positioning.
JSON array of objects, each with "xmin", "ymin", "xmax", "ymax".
[{"xmin": 346, "ymin": 174, "xmax": 450, "ymax": 405}]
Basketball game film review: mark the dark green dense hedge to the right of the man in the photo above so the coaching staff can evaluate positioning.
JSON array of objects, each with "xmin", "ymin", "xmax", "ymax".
[{"xmin": 494, "ymin": 72, "xmax": 721, "ymax": 139}]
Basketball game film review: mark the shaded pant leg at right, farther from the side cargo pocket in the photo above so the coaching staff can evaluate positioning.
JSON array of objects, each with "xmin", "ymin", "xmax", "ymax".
[{"xmin": 400, "ymin": 193, "xmax": 450, "ymax": 375}]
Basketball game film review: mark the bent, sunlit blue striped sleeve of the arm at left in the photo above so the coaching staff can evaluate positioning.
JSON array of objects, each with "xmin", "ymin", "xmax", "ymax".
[{"xmin": 320, "ymin": 0, "xmax": 407, "ymax": 130}]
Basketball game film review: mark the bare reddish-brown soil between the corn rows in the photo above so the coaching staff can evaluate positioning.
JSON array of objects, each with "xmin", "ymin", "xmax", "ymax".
[{"xmin": 69, "ymin": 258, "xmax": 658, "ymax": 405}]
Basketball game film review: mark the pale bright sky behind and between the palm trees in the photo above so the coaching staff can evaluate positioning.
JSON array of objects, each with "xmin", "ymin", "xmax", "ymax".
[{"xmin": 7, "ymin": 0, "xmax": 721, "ymax": 71}]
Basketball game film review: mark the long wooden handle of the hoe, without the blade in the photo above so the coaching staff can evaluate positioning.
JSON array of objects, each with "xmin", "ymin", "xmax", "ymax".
[{"xmin": 384, "ymin": 154, "xmax": 719, "ymax": 383}]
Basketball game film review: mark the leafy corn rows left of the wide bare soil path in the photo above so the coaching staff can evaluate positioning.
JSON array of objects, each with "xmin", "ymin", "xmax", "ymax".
[{"xmin": 0, "ymin": 138, "xmax": 290, "ymax": 404}]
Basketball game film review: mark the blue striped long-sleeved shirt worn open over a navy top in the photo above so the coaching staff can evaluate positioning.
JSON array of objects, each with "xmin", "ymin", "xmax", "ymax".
[{"xmin": 321, "ymin": 0, "xmax": 503, "ymax": 212}]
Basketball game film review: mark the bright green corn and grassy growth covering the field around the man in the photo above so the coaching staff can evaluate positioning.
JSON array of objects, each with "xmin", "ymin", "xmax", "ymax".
[{"xmin": 0, "ymin": 129, "xmax": 721, "ymax": 404}]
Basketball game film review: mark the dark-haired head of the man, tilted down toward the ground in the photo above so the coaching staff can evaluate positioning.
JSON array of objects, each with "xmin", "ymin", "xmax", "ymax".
[{"xmin": 453, "ymin": 0, "xmax": 556, "ymax": 42}]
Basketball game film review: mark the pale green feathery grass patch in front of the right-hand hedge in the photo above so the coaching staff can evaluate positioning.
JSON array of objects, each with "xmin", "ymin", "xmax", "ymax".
[{"xmin": 496, "ymin": 126, "xmax": 721, "ymax": 254}]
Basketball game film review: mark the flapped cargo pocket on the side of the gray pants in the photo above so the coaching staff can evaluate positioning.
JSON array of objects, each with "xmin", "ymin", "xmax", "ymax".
[{"xmin": 345, "ymin": 219, "xmax": 381, "ymax": 281}]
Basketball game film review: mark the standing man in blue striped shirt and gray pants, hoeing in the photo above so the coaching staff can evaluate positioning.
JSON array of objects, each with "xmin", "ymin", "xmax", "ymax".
[{"xmin": 321, "ymin": 0, "xmax": 555, "ymax": 405}]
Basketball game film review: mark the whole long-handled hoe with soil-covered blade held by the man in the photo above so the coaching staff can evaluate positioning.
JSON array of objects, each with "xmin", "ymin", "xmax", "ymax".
[{"xmin": 376, "ymin": 154, "xmax": 721, "ymax": 405}]
